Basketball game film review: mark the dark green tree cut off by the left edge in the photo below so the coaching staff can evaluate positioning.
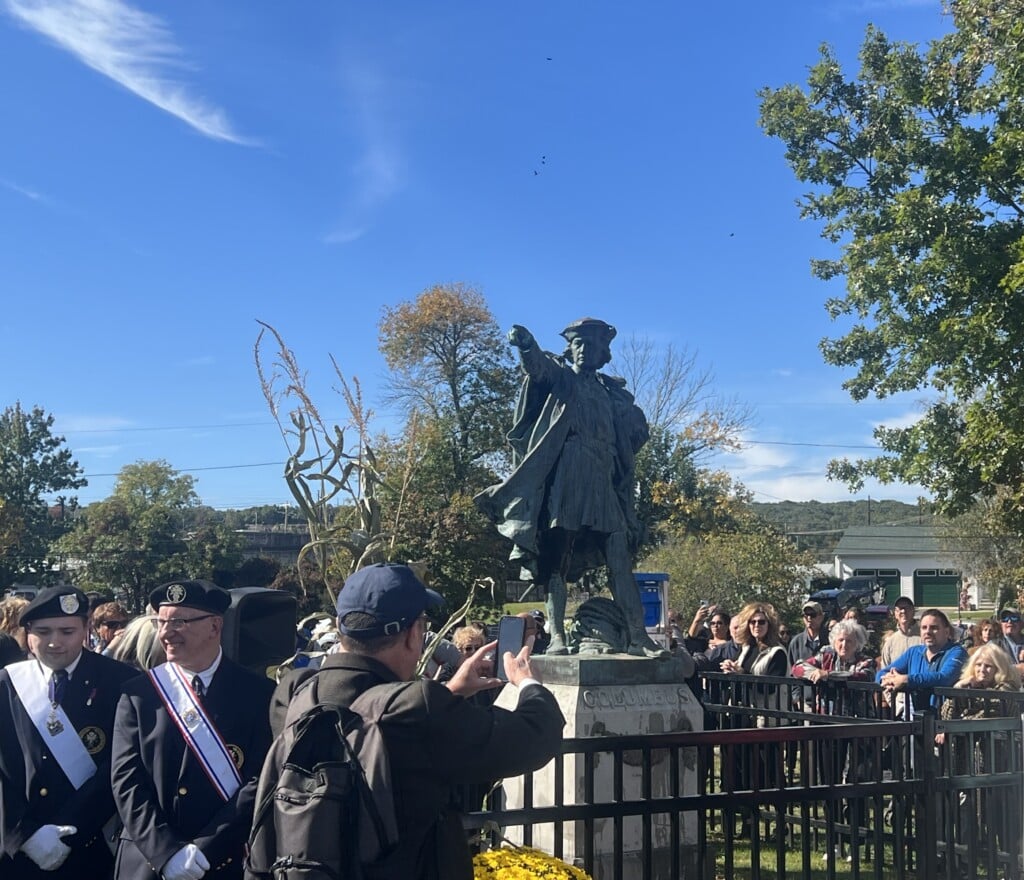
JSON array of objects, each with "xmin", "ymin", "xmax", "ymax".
[{"xmin": 0, "ymin": 403, "xmax": 86, "ymax": 586}]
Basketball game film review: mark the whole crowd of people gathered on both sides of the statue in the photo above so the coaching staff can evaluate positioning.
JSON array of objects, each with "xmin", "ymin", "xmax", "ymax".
[{"xmin": 0, "ymin": 565, "xmax": 1024, "ymax": 880}]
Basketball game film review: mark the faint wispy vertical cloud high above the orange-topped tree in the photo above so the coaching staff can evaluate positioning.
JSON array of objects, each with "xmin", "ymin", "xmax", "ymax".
[{"xmin": 325, "ymin": 65, "xmax": 406, "ymax": 244}]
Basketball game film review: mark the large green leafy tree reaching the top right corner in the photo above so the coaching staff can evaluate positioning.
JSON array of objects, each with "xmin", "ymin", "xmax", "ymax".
[{"xmin": 760, "ymin": 0, "xmax": 1024, "ymax": 530}]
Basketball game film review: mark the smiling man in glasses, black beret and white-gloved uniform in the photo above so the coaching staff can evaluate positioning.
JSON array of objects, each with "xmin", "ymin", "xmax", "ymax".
[{"xmin": 112, "ymin": 581, "xmax": 273, "ymax": 880}]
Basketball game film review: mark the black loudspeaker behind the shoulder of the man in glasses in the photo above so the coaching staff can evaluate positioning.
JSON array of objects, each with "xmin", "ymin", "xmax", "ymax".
[{"xmin": 221, "ymin": 587, "xmax": 298, "ymax": 675}]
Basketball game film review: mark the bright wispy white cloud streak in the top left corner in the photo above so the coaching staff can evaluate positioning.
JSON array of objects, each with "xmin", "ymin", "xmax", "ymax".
[{"xmin": 2, "ymin": 0, "xmax": 255, "ymax": 145}]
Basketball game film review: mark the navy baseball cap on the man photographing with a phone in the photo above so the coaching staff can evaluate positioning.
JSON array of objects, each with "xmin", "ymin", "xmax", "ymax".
[{"xmin": 337, "ymin": 562, "xmax": 444, "ymax": 638}]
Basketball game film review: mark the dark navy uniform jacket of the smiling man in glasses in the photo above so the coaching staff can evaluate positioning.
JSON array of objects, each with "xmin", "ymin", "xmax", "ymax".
[{"xmin": 112, "ymin": 657, "xmax": 273, "ymax": 880}]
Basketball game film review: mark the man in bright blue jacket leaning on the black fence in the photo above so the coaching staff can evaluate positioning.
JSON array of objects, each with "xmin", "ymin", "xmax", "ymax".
[{"xmin": 876, "ymin": 609, "xmax": 967, "ymax": 710}]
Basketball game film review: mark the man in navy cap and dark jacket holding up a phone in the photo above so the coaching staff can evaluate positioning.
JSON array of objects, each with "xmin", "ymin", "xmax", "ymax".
[{"xmin": 260, "ymin": 564, "xmax": 565, "ymax": 880}]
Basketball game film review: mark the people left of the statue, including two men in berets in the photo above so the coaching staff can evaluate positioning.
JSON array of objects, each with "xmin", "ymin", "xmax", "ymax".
[{"xmin": 0, "ymin": 564, "xmax": 564, "ymax": 880}]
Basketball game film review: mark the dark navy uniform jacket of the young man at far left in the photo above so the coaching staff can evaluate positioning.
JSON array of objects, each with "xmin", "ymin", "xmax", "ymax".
[{"xmin": 0, "ymin": 651, "xmax": 138, "ymax": 880}]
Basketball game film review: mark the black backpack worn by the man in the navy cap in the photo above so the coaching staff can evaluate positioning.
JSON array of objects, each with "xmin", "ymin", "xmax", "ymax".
[{"xmin": 246, "ymin": 676, "xmax": 411, "ymax": 880}]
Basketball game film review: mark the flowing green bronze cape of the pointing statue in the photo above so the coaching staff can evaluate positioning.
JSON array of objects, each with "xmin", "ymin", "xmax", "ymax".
[{"xmin": 475, "ymin": 354, "xmax": 648, "ymax": 574}]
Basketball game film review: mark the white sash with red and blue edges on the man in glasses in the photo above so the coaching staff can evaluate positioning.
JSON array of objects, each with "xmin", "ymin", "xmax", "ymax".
[{"xmin": 150, "ymin": 662, "xmax": 242, "ymax": 800}]
